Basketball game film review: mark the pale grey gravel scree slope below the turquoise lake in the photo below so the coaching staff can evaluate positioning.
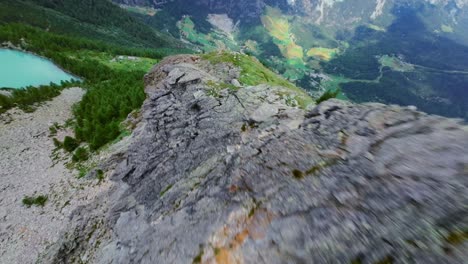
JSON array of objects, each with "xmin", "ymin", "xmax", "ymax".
[{"xmin": 0, "ymin": 88, "xmax": 105, "ymax": 264}]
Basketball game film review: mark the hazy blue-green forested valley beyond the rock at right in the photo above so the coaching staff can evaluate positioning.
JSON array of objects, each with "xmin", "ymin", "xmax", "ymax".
[{"xmin": 323, "ymin": 5, "xmax": 468, "ymax": 119}]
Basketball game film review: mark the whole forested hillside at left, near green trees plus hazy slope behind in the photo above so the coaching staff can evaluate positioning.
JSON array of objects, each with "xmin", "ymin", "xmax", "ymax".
[{"xmin": 0, "ymin": 0, "xmax": 195, "ymax": 150}]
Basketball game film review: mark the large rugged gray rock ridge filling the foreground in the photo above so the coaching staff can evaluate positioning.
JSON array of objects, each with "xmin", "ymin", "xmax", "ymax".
[{"xmin": 43, "ymin": 56, "xmax": 468, "ymax": 263}]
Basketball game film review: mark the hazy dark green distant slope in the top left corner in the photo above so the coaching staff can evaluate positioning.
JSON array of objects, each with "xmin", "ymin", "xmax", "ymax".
[{"xmin": 0, "ymin": 0, "xmax": 183, "ymax": 48}]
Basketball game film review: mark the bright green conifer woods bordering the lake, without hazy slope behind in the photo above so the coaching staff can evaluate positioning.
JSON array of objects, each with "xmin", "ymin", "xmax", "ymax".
[{"xmin": 0, "ymin": 24, "xmax": 185, "ymax": 150}]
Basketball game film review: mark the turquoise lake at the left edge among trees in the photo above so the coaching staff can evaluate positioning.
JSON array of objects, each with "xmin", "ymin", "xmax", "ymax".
[{"xmin": 0, "ymin": 49, "xmax": 78, "ymax": 88}]
